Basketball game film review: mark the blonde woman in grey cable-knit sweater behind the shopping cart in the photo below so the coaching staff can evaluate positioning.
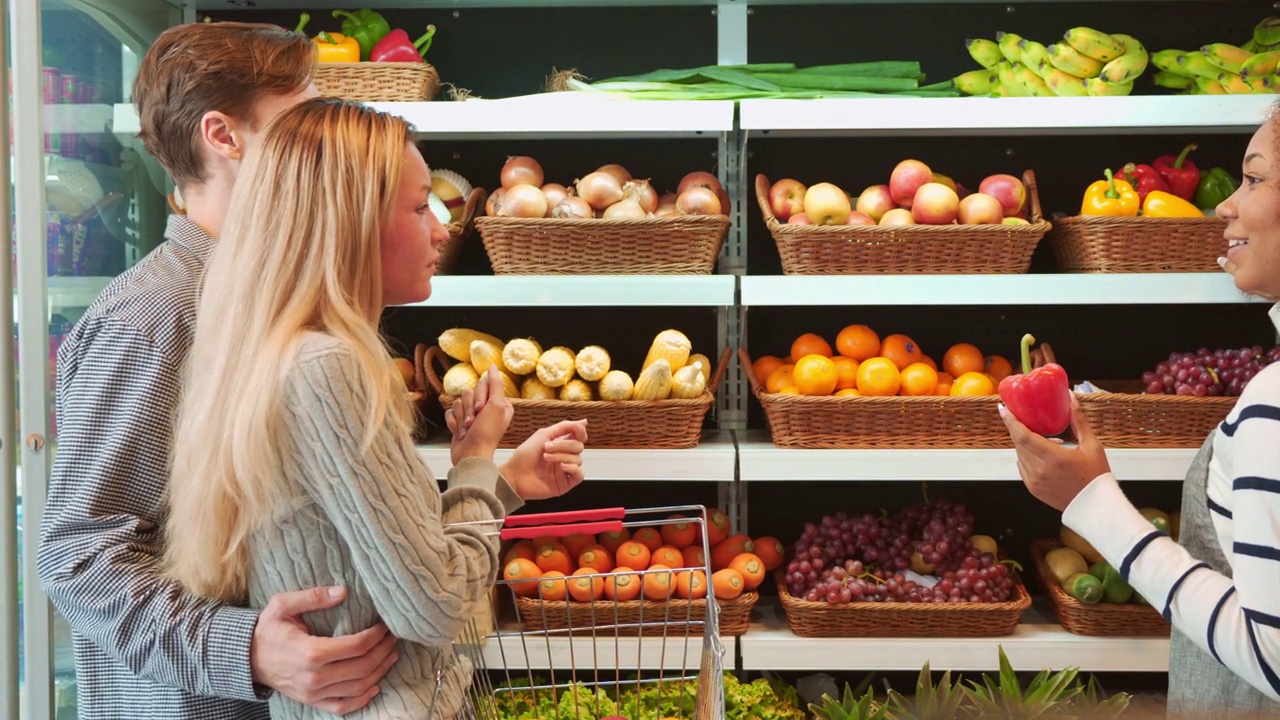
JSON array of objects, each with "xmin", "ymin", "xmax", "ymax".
[{"xmin": 165, "ymin": 99, "xmax": 586, "ymax": 719}]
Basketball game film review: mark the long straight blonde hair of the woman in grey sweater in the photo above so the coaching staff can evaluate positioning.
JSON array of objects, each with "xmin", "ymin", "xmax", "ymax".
[{"xmin": 165, "ymin": 99, "xmax": 410, "ymax": 602}]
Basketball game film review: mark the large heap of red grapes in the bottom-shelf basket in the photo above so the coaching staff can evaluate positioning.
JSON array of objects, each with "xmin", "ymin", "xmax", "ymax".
[{"xmin": 785, "ymin": 497, "xmax": 1014, "ymax": 605}]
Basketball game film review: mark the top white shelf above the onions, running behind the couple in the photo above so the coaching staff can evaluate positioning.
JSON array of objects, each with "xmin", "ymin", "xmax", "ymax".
[{"xmin": 114, "ymin": 95, "xmax": 733, "ymax": 140}]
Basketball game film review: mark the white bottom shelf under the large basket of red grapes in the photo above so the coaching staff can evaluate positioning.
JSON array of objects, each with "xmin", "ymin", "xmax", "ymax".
[{"xmin": 739, "ymin": 603, "xmax": 1169, "ymax": 673}]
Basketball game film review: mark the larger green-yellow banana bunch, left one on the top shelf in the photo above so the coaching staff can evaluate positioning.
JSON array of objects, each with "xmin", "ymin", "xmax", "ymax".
[{"xmin": 951, "ymin": 27, "xmax": 1151, "ymax": 97}]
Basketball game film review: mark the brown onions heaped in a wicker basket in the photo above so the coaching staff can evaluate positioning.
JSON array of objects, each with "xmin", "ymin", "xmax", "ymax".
[{"xmin": 485, "ymin": 155, "xmax": 730, "ymax": 220}]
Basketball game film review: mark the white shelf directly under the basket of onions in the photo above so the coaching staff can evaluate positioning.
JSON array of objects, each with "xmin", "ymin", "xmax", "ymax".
[{"xmin": 412, "ymin": 275, "xmax": 735, "ymax": 307}]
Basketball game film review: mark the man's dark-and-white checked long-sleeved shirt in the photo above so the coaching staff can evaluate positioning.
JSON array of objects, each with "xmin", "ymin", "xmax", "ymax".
[{"xmin": 38, "ymin": 215, "xmax": 268, "ymax": 720}]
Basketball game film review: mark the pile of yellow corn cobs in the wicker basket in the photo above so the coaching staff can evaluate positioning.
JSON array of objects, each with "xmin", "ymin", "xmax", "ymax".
[{"xmin": 436, "ymin": 328, "xmax": 714, "ymax": 402}]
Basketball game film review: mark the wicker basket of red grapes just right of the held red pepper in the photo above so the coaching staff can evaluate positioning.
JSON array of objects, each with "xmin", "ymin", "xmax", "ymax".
[{"xmin": 1075, "ymin": 380, "xmax": 1238, "ymax": 448}]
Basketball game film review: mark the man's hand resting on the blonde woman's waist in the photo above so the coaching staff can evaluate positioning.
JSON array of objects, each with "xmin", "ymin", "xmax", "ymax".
[{"xmin": 250, "ymin": 588, "xmax": 399, "ymax": 715}]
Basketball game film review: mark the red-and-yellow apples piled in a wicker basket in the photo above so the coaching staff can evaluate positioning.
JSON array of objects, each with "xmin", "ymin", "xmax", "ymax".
[{"xmin": 769, "ymin": 159, "xmax": 1028, "ymax": 225}]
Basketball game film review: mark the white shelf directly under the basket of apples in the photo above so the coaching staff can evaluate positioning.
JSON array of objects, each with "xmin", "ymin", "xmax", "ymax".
[{"xmin": 742, "ymin": 273, "xmax": 1265, "ymax": 306}]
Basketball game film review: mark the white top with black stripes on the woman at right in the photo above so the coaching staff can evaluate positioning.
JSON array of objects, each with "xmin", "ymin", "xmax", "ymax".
[{"xmin": 1062, "ymin": 299, "xmax": 1280, "ymax": 700}]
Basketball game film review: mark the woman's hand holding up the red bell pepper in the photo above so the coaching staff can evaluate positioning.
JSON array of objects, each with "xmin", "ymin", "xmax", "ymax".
[{"xmin": 1000, "ymin": 395, "xmax": 1111, "ymax": 512}]
